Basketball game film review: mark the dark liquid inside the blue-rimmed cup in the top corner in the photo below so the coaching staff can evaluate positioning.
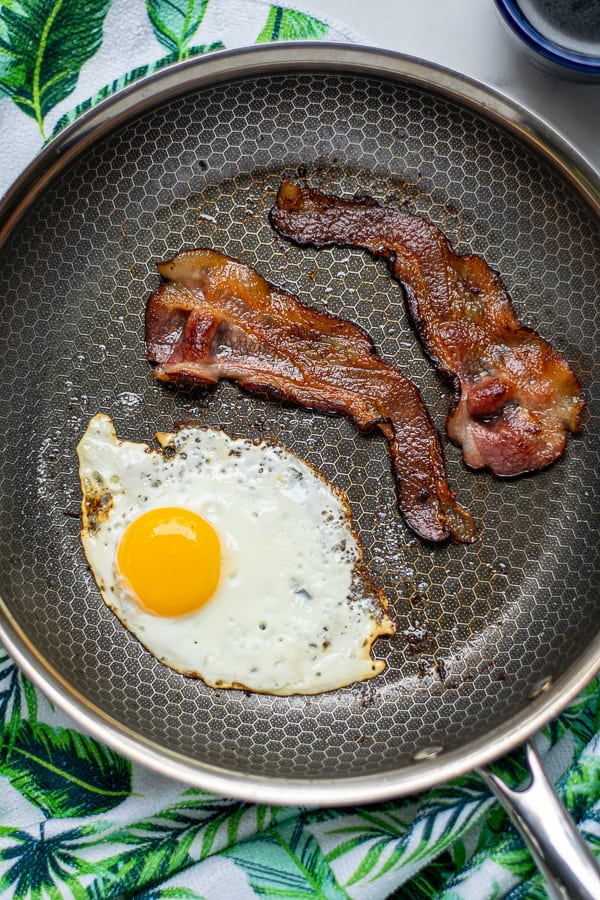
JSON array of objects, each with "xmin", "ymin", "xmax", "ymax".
[{"xmin": 519, "ymin": 0, "xmax": 600, "ymax": 57}]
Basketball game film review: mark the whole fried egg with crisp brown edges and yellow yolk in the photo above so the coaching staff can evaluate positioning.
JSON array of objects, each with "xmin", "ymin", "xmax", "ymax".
[{"xmin": 77, "ymin": 413, "xmax": 394, "ymax": 695}]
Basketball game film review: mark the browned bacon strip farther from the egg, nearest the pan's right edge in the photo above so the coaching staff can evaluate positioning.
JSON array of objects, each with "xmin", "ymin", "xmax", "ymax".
[{"xmin": 271, "ymin": 181, "xmax": 583, "ymax": 475}]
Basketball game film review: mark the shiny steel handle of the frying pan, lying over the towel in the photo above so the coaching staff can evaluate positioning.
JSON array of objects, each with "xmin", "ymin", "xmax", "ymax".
[{"xmin": 477, "ymin": 741, "xmax": 600, "ymax": 900}]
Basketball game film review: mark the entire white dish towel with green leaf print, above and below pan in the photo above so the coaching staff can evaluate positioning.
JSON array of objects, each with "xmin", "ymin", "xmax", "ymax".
[{"xmin": 0, "ymin": 0, "xmax": 600, "ymax": 900}]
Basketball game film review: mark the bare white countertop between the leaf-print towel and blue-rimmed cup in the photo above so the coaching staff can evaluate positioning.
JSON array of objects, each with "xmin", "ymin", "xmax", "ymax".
[{"xmin": 312, "ymin": 0, "xmax": 600, "ymax": 172}]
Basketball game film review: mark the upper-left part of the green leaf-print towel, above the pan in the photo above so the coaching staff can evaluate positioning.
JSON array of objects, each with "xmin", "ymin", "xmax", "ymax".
[{"xmin": 0, "ymin": 0, "xmax": 359, "ymax": 195}]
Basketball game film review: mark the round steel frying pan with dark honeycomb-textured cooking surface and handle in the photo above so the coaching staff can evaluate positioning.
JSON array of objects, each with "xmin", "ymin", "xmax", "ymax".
[{"xmin": 0, "ymin": 44, "xmax": 600, "ymax": 897}]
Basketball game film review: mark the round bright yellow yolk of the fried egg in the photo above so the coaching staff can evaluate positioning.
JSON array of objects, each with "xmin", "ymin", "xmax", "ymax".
[{"xmin": 117, "ymin": 507, "xmax": 221, "ymax": 616}]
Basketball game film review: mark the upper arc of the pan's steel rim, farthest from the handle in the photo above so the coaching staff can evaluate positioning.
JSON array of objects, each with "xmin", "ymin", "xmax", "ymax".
[{"xmin": 0, "ymin": 41, "xmax": 600, "ymax": 236}]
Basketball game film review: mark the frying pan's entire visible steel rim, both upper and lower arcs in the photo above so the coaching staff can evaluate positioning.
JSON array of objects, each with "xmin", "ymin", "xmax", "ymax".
[{"xmin": 0, "ymin": 42, "xmax": 600, "ymax": 806}]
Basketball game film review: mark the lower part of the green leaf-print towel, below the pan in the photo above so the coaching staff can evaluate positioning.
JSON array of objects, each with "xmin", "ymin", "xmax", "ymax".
[{"xmin": 0, "ymin": 658, "xmax": 600, "ymax": 900}]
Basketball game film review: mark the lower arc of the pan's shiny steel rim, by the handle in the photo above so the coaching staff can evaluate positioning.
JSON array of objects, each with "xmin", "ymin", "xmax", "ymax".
[{"xmin": 0, "ymin": 598, "xmax": 600, "ymax": 807}]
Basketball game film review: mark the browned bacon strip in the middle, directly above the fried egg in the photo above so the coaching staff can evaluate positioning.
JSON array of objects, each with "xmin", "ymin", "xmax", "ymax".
[{"xmin": 146, "ymin": 249, "xmax": 473, "ymax": 541}]
